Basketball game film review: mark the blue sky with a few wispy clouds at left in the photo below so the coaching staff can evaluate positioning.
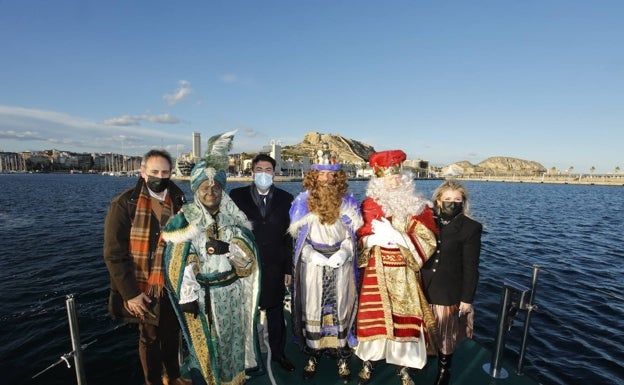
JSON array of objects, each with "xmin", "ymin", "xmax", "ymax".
[{"xmin": 0, "ymin": 0, "xmax": 624, "ymax": 174}]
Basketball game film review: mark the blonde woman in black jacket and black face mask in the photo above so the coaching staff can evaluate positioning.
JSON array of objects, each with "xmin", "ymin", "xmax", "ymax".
[{"xmin": 421, "ymin": 180, "xmax": 483, "ymax": 385}]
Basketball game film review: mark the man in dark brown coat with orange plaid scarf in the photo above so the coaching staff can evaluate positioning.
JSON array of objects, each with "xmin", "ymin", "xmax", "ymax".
[{"xmin": 104, "ymin": 150, "xmax": 190, "ymax": 385}]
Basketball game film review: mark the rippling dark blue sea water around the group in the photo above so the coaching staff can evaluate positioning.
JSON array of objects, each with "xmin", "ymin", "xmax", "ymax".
[{"xmin": 0, "ymin": 175, "xmax": 624, "ymax": 385}]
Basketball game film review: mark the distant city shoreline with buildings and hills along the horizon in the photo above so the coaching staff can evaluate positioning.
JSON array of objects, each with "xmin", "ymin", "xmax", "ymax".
[{"xmin": 6, "ymin": 132, "xmax": 624, "ymax": 184}]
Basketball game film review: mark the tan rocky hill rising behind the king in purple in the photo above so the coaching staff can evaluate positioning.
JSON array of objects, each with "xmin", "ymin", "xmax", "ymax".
[{"xmin": 282, "ymin": 132, "xmax": 375, "ymax": 164}]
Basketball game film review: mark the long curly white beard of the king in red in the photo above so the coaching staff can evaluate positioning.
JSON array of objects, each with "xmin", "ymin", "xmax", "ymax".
[{"xmin": 366, "ymin": 174, "xmax": 431, "ymax": 221}]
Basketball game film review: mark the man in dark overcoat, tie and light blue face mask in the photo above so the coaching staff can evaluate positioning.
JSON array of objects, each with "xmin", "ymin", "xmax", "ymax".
[{"xmin": 230, "ymin": 154, "xmax": 295, "ymax": 372}]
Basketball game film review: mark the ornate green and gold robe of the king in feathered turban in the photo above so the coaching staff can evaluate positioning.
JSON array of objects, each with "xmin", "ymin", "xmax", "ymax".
[{"xmin": 163, "ymin": 194, "xmax": 263, "ymax": 385}]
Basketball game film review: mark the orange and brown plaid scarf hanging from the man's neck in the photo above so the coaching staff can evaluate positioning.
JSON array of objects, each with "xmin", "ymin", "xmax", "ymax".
[{"xmin": 130, "ymin": 186, "xmax": 172, "ymax": 297}]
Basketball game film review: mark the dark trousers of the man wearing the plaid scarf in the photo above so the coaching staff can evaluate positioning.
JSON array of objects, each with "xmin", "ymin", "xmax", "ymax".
[{"xmin": 139, "ymin": 293, "xmax": 180, "ymax": 385}]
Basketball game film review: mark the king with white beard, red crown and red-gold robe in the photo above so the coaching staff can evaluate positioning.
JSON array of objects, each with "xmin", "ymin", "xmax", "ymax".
[{"xmin": 355, "ymin": 150, "xmax": 437, "ymax": 385}]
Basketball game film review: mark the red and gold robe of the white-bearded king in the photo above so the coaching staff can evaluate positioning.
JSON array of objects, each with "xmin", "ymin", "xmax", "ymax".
[{"xmin": 355, "ymin": 198, "xmax": 437, "ymax": 368}]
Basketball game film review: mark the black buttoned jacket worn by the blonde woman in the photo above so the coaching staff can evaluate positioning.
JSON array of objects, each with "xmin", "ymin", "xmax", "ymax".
[{"xmin": 421, "ymin": 214, "xmax": 483, "ymax": 306}]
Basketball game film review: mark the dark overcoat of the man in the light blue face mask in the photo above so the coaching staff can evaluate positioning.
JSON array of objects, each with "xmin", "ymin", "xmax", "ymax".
[{"xmin": 229, "ymin": 183, "xmax": 294, "ymax": 309}]
